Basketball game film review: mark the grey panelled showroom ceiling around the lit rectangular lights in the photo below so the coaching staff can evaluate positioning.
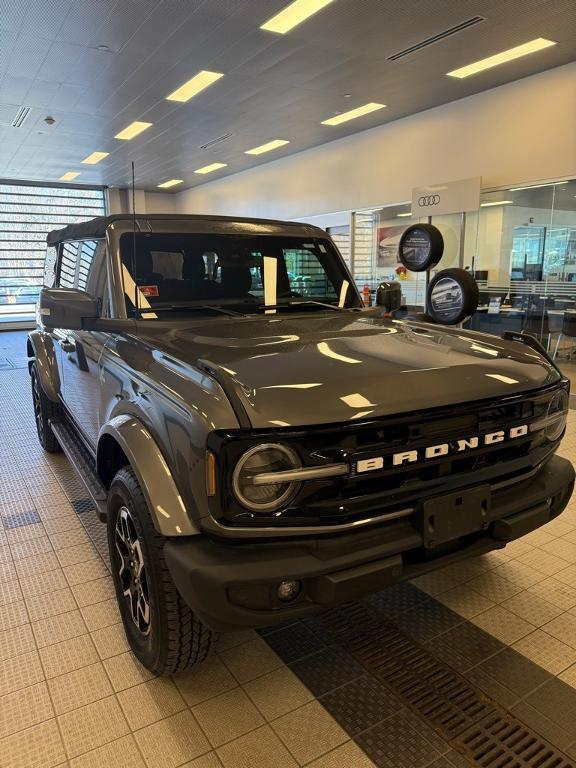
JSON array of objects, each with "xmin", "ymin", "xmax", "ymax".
[{"xmin": 0, "ymin": 0, "xmax": 576, "ymax": 191}]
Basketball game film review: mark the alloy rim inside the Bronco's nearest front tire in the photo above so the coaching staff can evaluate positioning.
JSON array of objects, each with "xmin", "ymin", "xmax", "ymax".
[{"xmin": 114, "ymin": 506, "xmax": 151, "ymax": 635}]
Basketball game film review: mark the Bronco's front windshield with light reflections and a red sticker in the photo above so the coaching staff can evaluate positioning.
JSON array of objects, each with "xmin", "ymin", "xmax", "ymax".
[{"xmin": 120, "ymin": 233, "xmax": 360, "ymax": 318}]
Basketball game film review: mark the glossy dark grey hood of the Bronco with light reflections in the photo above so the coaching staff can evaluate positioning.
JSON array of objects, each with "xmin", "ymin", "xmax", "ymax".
[{"xmin": 138, "ymin": 312, "xmax": 560, "ymax": 428}]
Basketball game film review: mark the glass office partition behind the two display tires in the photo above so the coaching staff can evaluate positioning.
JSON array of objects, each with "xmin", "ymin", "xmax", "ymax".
[{"xmin": 351, "ymin": 180, "xmax": 576, "ymax": 380}]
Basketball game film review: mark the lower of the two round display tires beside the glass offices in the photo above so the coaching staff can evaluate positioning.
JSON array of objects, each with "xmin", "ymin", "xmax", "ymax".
[{"xmin": 426, "ymin": 268, "xmax": 478, "ymax": 325}]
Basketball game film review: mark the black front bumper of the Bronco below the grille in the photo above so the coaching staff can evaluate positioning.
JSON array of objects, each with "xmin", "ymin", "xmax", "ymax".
[{"xmin": 164, "ymin": 456, "xmax": 574, "ymax": 631}]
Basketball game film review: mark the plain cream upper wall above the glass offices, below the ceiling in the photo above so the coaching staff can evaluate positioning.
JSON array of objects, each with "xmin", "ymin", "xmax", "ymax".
[{"xmin": 175, "ymin": 62, "xmax": 576, "ymax": 219}]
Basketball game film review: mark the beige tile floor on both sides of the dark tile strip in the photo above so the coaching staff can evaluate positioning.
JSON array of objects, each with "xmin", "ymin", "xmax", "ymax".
[{"xmin": 0, "ymin": 340, "xmax": 576, "ymax": 768}]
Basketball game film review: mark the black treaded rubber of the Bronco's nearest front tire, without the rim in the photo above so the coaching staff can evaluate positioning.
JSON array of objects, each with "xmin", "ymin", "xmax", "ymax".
[{"xmin": 108, "ymin": 467, "xmax": 215, "ymax": 675}]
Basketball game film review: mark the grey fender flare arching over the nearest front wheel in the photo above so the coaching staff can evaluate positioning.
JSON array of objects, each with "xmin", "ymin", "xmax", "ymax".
[{"xmin": 97, "ymin": 415, "xmax": 200, "ymax": 536}]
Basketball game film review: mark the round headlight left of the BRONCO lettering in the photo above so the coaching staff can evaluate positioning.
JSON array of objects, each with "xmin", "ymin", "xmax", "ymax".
[{"xmin": 232, "ymin": 443, "xmax": 301, "ymax": 512}]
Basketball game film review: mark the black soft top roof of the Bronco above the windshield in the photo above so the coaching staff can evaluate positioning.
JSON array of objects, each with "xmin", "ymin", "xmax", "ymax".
[{"xmin": 46, "ymin": 213, "xmax": 326, "ymax": 245}]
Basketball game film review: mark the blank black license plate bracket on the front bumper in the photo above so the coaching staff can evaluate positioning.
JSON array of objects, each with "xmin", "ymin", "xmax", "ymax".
[{"xmin": 418, "ymin": 485, "xmax": 491, "ymax": 549}]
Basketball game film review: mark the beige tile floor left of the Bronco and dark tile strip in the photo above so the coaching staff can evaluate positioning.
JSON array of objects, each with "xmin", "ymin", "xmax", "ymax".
[{"xmin": 0, "ymin": 369, "xmax": 373, "ymax": 768}]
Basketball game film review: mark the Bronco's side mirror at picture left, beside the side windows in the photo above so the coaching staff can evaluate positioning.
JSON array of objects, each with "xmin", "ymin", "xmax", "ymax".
[{"xmin": 37, "ymin": 288, "xmax": 100, "ymax": 331}]
